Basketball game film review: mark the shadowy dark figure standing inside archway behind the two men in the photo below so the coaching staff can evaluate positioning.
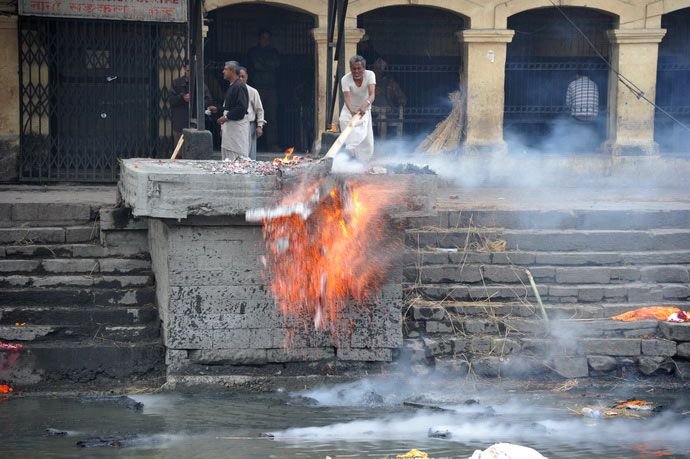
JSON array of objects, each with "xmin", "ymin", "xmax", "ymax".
[{"xmin": 247, "ymin": 29, "xmax": 282, "ymax": 152}]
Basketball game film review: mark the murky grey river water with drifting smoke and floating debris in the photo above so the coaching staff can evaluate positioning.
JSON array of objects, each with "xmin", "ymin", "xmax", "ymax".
[{"xmin": 0, "ymin": 379, "xmax": 690, "ymax": 459}]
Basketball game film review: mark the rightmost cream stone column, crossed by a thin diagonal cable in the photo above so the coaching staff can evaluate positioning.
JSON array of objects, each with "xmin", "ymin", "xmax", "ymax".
[{"xmin": 605, "ymin": 29, "xmax": 666, "ymax": 156}]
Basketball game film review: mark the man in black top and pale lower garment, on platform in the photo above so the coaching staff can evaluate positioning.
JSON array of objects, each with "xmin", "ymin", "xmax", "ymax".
[{"xmin": 218, "ymin": 61, "xmax": 249, "ymax": 161}]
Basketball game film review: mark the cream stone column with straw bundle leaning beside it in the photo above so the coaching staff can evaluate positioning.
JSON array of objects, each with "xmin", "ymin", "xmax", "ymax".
[{"xmin": 457, "ymin": 29, "xmax": 515, "ymax": 152}]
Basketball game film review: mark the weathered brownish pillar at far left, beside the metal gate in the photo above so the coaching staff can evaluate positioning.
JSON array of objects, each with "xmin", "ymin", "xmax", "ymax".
[{"xmin": 0, "ymin": 16, "xmax": 19, "ymax": 182}]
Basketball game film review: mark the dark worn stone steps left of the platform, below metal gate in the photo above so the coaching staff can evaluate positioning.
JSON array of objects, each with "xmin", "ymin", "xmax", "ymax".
[{"xmin": 0, "ymin": 202, "xmax": 164, "ymax": 390}]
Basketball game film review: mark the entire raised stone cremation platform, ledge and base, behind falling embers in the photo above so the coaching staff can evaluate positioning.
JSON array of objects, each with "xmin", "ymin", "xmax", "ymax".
[{"xmin": 119, "ymin": 159, "xmax": 436, "ymax": 386}]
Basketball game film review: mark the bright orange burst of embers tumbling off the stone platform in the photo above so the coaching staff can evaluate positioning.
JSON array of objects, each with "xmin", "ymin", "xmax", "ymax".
[{"xmin": 264, "ymin": 177, "xmax": 401, "ymax": 333}]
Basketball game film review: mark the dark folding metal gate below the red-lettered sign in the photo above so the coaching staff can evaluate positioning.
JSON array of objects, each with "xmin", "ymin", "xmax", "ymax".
[{"xmin": 19, "ymin": 17, "xmax": 187, "ymax": 182}]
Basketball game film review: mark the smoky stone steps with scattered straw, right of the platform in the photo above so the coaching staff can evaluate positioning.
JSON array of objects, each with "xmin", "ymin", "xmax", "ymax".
[{"xmin": 404, "ymin": 210, "xmax": 690, "ymax": 378}]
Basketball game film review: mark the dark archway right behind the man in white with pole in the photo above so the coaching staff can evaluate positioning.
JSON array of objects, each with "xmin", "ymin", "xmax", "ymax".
[{"xmin": 357, "ymin": 6, "xmax": 466, "ymax": 141}]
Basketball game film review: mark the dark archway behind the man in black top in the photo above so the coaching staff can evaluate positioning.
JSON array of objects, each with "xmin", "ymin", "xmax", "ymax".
[{"xmin": 205, "ymin": 4, "xmax": 316, "ymax": 152}]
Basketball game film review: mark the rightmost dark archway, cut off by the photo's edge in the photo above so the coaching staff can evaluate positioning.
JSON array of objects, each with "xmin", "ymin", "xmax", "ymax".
[{"xmin": 654, "ymin": 8, "xmax": 690, "ymax": 154}]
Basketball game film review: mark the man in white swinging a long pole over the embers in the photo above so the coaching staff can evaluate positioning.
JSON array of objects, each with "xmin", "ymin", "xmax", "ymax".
[{"xmin": 339, "ymin": 56, "xmax": 376, "ymax": 161}]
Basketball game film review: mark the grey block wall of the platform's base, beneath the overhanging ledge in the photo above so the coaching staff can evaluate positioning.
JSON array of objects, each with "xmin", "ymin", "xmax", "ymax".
[{"xmin": 149, "ymin": 217, "xmax": 402, "ymax": 382}]
